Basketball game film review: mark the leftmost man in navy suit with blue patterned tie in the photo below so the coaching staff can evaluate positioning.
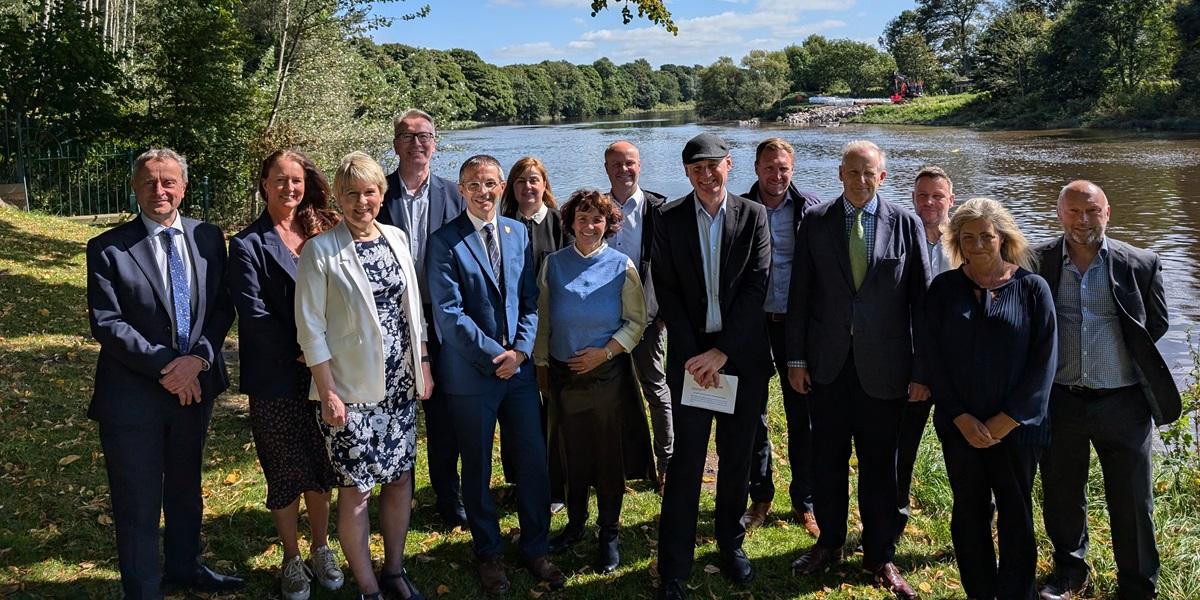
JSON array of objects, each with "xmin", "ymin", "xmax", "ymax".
[{"xmin": 88, "ymin": 149, "xmax": 242, "ymax": 599}]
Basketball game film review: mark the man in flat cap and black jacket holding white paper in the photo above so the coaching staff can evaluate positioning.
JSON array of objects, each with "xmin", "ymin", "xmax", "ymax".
[{"xmin": 653, "ymin": 133, "xmax": 772, "ymax": 600}]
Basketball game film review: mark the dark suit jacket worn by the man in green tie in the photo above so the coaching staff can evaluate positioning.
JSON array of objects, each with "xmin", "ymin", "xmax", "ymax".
[{"xmin": 786, "ymin": 196, "xmax": 931, "ymax": 398}]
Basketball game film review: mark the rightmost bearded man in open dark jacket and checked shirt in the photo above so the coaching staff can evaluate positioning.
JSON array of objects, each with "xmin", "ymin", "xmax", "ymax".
[{"xmin": 1036, "ymin": 180, "xmax": 1181, "ymax": 600}]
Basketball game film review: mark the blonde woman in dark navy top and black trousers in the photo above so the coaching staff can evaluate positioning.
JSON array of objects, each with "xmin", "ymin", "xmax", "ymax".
[{"xmin": 926, "ymin": 198, "xmax": 1057, "ymax": 600}]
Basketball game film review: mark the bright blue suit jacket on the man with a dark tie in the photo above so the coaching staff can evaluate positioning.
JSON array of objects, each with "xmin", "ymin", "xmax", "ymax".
[{"xmin": 426, "ymin": 212, "xmax": 538, "ymax": 395}]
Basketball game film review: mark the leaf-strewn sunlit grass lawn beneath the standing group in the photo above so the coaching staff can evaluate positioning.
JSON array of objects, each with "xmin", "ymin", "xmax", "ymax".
[{"xmin": 0, "ymin": 204, "xmax": 1200, "ymax": 599}]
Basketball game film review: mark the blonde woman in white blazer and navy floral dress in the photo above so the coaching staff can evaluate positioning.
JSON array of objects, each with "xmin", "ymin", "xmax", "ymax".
[{"xmin": 295, "ymin": 152, "xmax": 433, "ymax": 600}]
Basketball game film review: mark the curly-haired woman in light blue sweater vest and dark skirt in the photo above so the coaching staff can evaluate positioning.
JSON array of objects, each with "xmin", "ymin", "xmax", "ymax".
[{"xmin": 534, "ymin": 190, "xmax": 654, "ymax": 572}]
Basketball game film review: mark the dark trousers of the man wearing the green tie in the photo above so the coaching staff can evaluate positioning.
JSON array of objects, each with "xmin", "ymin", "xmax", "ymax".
[{"xmin": 811, "ymin": 353, "xmax": 905, "ymax": 566}]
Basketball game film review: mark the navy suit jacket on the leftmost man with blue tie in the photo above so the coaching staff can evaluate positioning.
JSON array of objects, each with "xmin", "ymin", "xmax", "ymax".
[{"xmin": 88, "ymin": 215, "xmax": 234, "ymax": 425}]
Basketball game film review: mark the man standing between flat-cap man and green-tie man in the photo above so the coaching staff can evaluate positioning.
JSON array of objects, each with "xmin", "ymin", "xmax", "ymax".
[{"xmin": 742, "ymin": 138, "xmax": 821, "ymax": 538}]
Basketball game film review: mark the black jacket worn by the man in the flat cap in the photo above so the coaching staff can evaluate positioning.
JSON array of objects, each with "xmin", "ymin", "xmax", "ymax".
[{"xmin": 653, "ymin": 192, "xmax": 774, "ymax": 379}]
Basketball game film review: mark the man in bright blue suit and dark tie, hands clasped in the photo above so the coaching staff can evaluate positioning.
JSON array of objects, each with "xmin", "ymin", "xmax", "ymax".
[{"xmin": 426, "ymin": 155, "xmax": 566, "ymax": 594}]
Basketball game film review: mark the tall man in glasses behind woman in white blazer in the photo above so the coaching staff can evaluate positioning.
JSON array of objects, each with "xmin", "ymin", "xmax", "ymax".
[{"xmin": 376, "ymin": 108, "xmax": 467, "ymax": 526}]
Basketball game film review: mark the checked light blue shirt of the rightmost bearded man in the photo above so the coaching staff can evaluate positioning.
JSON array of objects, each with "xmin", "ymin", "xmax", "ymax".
[{"xmin": 1054, "ymin": 238, "xmax": 1138, "ymax": 390}]
